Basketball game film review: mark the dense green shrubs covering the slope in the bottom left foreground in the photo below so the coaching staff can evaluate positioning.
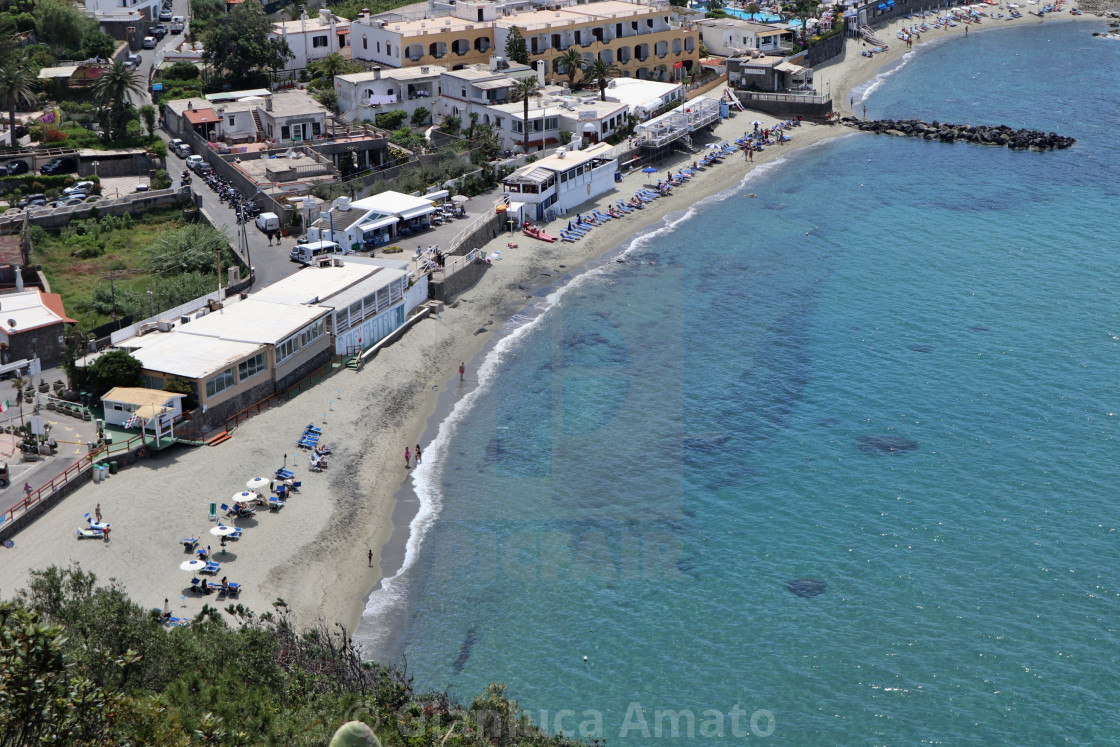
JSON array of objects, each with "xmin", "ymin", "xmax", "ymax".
[{"xmin": 0, "ymin": 567, "xmax": 595, "ymax": 747}]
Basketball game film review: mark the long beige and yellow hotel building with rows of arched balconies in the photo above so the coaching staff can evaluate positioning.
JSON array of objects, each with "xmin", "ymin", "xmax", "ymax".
[{"xmin": 351, "ymin": 0, "xmax": 700, "ymax": 82}]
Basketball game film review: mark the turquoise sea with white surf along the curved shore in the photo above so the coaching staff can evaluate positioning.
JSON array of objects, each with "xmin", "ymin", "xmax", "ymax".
[{"xmin": 357, "ymin": 22, "xmax": 1120, "ymax": 745}]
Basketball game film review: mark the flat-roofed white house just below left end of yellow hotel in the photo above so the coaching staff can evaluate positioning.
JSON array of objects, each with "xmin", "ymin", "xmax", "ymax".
[{"xmin": 335, "ymin": 65, "xmax": 447, "ymax": 122}]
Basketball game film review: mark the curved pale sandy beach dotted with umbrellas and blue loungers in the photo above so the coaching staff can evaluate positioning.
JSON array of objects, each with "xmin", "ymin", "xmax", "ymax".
[{"xmin": 0, "ymin": 7, "xmax": 1098, "ymax": 631}]
